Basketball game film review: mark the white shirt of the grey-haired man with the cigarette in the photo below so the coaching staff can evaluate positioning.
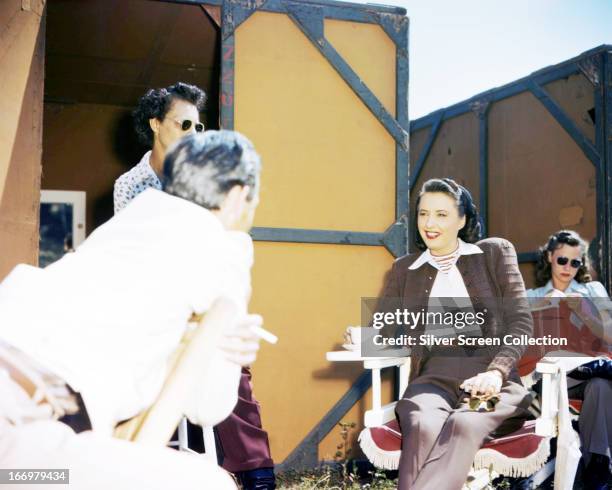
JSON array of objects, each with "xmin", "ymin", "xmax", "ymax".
[{"xmin": 0, "ymin": 189, "xmax": 253, "ymax": 431}]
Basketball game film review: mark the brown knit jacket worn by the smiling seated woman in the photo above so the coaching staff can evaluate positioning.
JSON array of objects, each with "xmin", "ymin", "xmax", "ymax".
[{"xmin": 382, "ymin": 238, "xmax": 533, "ymax": 381}]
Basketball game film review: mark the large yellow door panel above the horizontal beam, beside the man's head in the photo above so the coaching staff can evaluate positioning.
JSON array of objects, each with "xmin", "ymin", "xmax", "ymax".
[{"xmin": 234, "ymin": 12, "xmax": 395, "ymax": 232}]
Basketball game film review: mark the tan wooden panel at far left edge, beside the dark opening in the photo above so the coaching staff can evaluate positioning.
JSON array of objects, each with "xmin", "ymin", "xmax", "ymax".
[{"xmin": 0, "ymin": 0, "xmax": 45, "ymax": 280}]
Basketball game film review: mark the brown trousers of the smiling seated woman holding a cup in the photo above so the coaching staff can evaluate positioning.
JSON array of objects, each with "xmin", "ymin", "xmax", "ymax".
[{"xmin": 396, "ymin": 357, "xmax": 531, "ymax": 490}]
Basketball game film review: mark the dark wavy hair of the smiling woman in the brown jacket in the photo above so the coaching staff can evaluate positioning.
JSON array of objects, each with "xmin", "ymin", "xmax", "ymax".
[{"xmin": 414, "ymin": 178, "xmax": 482, "ymax": 250}]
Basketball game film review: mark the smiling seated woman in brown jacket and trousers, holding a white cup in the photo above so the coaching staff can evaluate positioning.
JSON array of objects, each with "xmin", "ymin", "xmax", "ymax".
[{"xmin": 383, "ymin": 179, "xmax": 533, "ymax": 490}]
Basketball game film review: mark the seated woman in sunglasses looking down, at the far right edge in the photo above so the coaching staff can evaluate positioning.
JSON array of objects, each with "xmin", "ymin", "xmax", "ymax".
[{"xmin": 527, "ymin": 230, "xmax": 612, "ymax": 490}]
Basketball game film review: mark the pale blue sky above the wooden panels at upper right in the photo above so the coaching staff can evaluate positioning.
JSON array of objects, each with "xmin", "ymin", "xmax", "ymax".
[{"xmin": 351, "ymin": 0, "xmax": 612, "ymax": 119}]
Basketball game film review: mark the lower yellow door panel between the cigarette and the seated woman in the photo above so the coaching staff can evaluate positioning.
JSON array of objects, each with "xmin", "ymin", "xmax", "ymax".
[{"xmin": 250, "ymin": 242, "xmax": 393, "ymax": 462}]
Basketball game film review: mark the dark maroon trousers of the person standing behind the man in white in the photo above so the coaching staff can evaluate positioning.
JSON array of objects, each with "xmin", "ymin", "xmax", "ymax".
[{"xmin": 216, "ymin": 368, "xmax": 274, "ymax": 473}]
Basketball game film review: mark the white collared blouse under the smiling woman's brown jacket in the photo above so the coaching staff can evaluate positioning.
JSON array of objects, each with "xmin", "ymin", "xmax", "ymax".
[{"xmin": 408, "ymin": 238, "xmax": 483, "ymax": 336}]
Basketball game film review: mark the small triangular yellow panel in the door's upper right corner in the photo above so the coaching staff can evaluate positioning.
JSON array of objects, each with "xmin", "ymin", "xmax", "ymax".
[{"xmin": 325, "ymin": 19, "xmax": 396, "ymax": 116}]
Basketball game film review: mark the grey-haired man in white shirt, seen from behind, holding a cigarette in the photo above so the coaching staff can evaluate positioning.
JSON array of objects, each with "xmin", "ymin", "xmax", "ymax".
[{"xmin": 0, "ymin": 131, "xmax": 262, "ymax": 490}]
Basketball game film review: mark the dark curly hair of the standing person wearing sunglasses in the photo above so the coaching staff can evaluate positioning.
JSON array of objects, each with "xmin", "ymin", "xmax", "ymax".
[{"xmin": 132, "ymin": 82, "xmax": 206, "ymax": 148}]
